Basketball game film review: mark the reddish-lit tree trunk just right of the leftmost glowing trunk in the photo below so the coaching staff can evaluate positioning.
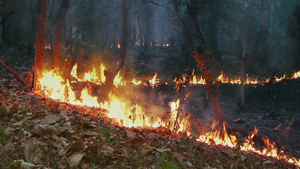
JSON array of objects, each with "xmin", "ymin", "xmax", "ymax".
[{"xmin": 53, "ymin": 0, "xmax": 70, "ymax": 68}]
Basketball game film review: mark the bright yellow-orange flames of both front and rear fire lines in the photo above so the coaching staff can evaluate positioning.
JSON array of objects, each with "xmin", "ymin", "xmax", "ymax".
[{"xmin": 37, "ymin": 67, "xmax": 300, "ymax": 167}]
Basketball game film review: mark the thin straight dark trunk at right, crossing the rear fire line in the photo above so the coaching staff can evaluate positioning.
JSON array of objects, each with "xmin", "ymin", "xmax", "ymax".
[{"xmin": 240, "ymin": 0, "xmax": 248, "ymax": 110}]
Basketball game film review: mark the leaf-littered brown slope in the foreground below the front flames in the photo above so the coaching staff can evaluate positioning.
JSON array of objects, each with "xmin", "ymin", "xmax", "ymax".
[{"xmin": 0, "ymin": 67, "xmax": 299, "ymax": 169}]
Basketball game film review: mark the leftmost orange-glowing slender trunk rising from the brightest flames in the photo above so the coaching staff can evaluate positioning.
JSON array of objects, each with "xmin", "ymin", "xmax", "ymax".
[{"xmin": 34, "ymin": 0, "xmax": 48, "ymax": 90}]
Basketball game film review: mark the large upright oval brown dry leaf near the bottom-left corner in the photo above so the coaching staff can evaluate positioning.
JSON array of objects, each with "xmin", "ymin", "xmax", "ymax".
[{"xmin": 23, "ymin": 139, "xmax": 43, "ymax": 164}]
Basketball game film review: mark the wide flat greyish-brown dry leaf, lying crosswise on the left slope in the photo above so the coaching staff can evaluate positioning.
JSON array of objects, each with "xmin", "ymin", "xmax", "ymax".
[{"xmin": 32, "ymin": 124, "xmax": 67, "ymax": 136}]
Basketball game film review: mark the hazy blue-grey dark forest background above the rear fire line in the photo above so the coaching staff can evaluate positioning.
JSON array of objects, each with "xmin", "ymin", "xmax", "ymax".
[{"xmin": 0, "ymin": 0, "xmax": 300, "ymax": 79}]
